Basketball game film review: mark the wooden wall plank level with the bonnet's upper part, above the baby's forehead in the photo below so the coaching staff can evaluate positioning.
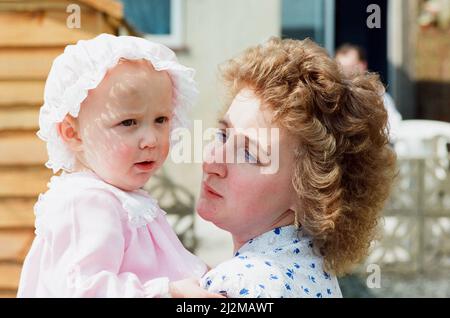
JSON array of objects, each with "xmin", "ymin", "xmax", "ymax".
[{"xmin": 0, "ymin": 47, "xmax": 64, "ymax": 80}]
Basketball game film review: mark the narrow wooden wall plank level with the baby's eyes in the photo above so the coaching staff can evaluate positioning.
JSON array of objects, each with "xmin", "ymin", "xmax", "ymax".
[{"xmin": 0, "ymin": 107, "xmax": 39, "ymax": 130}]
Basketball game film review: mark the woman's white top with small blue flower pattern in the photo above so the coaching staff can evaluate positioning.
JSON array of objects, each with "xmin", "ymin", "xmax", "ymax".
[{"xmin": 201, "ymin": 226, "xmax": 342, "ymax": 298}]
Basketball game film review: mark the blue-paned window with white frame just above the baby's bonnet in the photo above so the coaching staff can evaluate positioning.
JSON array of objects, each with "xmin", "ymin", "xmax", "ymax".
[{"xmin": 121, "ymin": 0, "xmax": 184, "ymax": 49}]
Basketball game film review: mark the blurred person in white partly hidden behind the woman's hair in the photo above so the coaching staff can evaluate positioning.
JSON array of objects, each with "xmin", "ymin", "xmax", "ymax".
[{"xmin": 336, "ymin": 44, "xmax": 402, "ymax": 142}]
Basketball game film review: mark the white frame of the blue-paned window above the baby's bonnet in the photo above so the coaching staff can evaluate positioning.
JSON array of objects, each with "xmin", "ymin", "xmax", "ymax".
[{"xmin": 119, "ymin": 0, "xmax": 185, "ymax": 50}]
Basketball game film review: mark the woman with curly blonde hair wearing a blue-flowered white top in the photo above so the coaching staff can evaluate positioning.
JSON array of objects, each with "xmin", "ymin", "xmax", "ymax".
[{"xmin": 197, "ymin": 38, "xmax": 395, "ymax": 297}]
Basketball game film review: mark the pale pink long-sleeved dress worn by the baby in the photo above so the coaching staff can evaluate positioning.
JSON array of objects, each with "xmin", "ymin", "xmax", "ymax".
[{"xmin": 17, "ymin": 172, "xmax": 206, "ymax": 297}]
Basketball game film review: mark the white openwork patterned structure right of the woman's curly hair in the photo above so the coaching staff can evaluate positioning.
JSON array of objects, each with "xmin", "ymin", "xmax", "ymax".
[{"xmin": 382, "ymin": 120, "xmax": 450, "ymax": 270}]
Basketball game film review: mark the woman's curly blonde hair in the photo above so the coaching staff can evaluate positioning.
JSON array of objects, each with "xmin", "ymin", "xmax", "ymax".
[{"xmin": 221, "ymin": 38, "xmax": 396, "ymax": 275}]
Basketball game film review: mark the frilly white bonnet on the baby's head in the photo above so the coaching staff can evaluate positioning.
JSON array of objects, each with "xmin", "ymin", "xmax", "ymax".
[{"xmin": 37, "ymin": 34, "xmax": 198, "ymax": 173}]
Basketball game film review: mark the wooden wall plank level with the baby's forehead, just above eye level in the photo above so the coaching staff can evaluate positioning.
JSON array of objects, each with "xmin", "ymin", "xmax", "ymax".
[{"xmin": 0, "ymin": 80, "xmax": 45, "ymax": 108}]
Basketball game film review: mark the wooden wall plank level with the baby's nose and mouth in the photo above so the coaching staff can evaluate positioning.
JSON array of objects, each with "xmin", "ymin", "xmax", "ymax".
[{"xmin": 0, "ymin": 131, "xmax": 48, "ymax": 166}]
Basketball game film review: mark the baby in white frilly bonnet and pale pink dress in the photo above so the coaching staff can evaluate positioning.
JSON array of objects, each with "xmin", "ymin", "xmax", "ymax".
[{"xmin": 18, "ymin": 34, "xmax": 220, "ymax": 297}]
